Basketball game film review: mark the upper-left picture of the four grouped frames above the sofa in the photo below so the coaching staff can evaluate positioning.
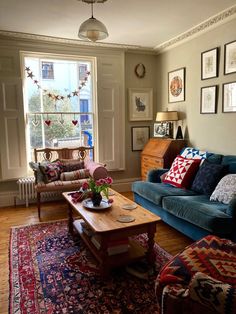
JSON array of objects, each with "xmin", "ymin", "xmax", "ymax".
[{"xmin": 201, "ymin": 48, "xmax": 218, "ymax": 80}]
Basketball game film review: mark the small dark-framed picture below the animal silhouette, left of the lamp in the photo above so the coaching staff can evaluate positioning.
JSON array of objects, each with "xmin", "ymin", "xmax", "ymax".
[{"xmin": 131, "ymin": 126, "xmax": 150, "ymax": 151}]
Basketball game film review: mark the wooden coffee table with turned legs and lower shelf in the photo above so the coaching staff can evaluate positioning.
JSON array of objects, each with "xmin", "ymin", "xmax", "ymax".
[{"xmin": 62, "ymin": 190, "xmax": 161, "ymax": 275}]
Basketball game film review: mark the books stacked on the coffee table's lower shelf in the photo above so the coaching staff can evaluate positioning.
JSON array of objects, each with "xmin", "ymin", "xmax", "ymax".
[{"xmin": 91, "ymin": 234, "xmax": 129, "ymax": 256}]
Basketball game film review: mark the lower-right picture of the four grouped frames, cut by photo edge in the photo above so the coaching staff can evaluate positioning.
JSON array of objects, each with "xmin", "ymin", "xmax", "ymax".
[{"xmin": 223, "ymin": 82, "xmax": 236, "ymax": 112}]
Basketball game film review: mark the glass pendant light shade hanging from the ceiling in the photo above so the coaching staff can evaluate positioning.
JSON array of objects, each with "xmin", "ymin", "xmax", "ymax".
[{"xmin": 78, "ymin": 17, "xmax": 108, "ymax": 42}]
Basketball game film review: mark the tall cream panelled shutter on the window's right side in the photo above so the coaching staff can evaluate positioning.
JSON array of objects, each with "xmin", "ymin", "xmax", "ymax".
[{"xmin": 97, "ymin": 53, "xmax": 125, "ymax": 170}]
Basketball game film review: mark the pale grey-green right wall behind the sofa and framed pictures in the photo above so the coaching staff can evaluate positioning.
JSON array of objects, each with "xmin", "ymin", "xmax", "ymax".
[{"xmin": 156, "ymin": 19, "xmax": 236, "ymax": 154}]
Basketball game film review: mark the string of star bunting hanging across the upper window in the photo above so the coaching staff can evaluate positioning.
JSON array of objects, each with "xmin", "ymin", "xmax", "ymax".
[{"xmin": 25, "ymin": 67, "xmax": 90, "ymax": 101}]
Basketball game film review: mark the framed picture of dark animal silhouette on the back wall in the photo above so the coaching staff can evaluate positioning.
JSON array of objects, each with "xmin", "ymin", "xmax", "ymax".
[{"xmin": 129, "ymin": 88, "xmax": 153, "ymax": 121}]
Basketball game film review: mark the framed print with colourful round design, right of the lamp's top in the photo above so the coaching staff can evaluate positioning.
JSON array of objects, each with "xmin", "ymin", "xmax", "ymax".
[{"xmin": 168, "ymin": 68, "xmax": 185, "ymax": 103}]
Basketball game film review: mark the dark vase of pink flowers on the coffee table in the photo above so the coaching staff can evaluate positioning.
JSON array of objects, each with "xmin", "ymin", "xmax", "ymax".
[{"xmin": 82, "ymin": 177, "xmax": 113, "ymax": 207}]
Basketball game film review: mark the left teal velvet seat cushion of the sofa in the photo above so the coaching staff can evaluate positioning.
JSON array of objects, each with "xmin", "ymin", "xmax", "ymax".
[{"xmin": 132, "ymin": 181, "xmax": 196, "ymax": 206}]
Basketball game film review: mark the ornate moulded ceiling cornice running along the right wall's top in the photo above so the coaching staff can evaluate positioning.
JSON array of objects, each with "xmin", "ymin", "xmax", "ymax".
[{"xmin": 154, "ymin": 5, "xmax": 236, "ymax": 54}]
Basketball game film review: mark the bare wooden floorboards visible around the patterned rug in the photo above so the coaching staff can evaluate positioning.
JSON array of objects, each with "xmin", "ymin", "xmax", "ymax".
[{"xmin": 0, "ymin": 192, "xmax": 192, "ymax": 314}]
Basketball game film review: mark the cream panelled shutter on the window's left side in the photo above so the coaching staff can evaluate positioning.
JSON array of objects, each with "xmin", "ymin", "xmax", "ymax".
[{"xmin": 0, "ymin": 77, "xmax": 27, "ymax": 180}]
